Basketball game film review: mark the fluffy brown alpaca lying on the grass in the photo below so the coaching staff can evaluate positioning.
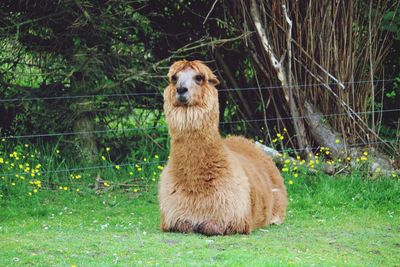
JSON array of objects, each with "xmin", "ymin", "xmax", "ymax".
[{"xmin": 159, "ymin": 60, "xmax": 286, "ymax": 235}]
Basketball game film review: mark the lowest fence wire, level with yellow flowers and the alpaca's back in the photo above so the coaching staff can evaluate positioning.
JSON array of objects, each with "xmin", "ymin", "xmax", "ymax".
[{"xmin": 0, "ymin": 139, "xmax": 400, "ymax": 177}]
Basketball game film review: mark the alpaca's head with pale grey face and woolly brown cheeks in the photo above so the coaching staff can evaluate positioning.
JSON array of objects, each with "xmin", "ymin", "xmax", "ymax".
[{"xmin": 164, "ymin": 60, "xmax": 219, "ymax": 130}]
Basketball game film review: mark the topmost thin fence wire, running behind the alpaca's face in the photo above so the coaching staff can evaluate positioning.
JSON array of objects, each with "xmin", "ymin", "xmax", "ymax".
[{"xmin": 0, "ymin": 79, "xmax": 396, "ymax": 103}]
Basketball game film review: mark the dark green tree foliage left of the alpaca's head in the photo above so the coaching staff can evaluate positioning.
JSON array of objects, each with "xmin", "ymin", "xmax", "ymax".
[{"xmin": 0, "ymin": 1, "xmax": 161, "ymax": 144}]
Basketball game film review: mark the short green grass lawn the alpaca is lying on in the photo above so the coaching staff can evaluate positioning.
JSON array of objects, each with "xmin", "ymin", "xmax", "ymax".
[{"xmin": 0, "ymin": 175, "xmax": 400, "ymax": 266}]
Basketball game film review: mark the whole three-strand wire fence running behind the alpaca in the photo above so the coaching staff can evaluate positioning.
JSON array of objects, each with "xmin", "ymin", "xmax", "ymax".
[{"xmin": 0, "ymin": 79, "xmax": 400, "ymax": 181}]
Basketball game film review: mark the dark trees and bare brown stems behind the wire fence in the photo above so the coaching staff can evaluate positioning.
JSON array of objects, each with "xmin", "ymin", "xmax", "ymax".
[{"xmin": 0, "ymin": 0, "xmax": 400, "ymax": 168}]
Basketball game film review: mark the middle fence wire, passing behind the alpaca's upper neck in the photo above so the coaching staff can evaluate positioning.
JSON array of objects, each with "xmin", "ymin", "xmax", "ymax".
[{"xmin": 0, "ymin": 108, "xmax": 400, "ymax": 139}]
